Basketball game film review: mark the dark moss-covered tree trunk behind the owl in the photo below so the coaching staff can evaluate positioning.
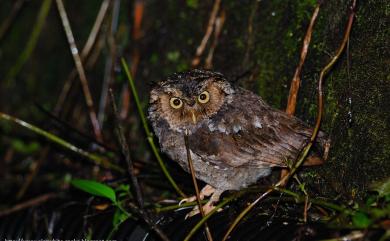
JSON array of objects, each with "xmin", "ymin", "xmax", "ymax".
[{"xmin": 212, "ymin": 0, "xmax": 390, "ymax": 198}]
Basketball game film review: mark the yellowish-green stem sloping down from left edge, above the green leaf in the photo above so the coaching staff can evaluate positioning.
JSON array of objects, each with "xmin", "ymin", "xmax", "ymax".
[{"xmin": 0, "ymin": 112, "xmax": 124, "ymax": 172}]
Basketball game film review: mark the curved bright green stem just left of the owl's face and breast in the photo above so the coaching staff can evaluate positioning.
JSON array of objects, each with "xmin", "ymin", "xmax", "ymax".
[{"xmin": 121, "ymin": 58, "xmax": 186, "ymax": 197}]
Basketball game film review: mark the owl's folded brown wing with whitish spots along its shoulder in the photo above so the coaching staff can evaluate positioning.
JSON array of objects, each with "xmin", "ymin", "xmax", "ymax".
[{"xmin": 189, "ymin": 89, "xmax": 324, "ymax": 168}]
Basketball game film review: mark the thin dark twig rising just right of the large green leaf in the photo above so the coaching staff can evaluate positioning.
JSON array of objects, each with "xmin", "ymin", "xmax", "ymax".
[{"xmin": 109, "ymin": 89, "xmax": 144, "ymax": 209}]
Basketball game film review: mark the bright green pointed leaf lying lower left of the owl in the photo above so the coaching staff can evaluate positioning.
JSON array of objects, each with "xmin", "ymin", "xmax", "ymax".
[{"xmin": 71, "ymin": 179, "xmax": 116, "ymax": 203}]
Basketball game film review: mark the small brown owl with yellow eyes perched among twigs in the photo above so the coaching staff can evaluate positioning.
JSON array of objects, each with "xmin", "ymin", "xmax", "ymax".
[{"xmin": 148, "ymin": 69, "xmax": 327, "ymax": 215}]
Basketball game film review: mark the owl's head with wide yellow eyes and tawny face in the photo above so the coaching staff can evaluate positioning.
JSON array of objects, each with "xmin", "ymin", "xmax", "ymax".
[{"xmin": 149, "ymin": 69, "xmax": 234, "ymax": 132}]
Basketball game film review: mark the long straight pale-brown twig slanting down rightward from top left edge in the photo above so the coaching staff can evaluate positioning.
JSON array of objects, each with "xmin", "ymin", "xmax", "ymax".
[{"xmin": 56, "ymin": 0, "xmax": 103, "ymax": 142}]
